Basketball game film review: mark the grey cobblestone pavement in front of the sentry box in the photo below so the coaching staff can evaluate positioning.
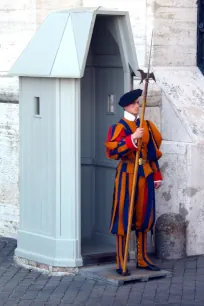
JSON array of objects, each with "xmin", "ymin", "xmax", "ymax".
[{"xmin": 0, "ymin": 237, "xmax": 204, "ymax": 306}]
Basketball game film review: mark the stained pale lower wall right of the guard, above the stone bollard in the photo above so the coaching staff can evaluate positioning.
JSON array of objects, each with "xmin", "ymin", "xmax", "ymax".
[{"xmin": 156, "ymin": 68, "xmax": 204, "ymax": 255}]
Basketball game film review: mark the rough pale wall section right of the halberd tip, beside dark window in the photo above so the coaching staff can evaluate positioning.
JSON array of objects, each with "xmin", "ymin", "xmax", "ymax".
[{"xmin": 147, "ymin": 0, "xmax": 197, "ymax": 66}]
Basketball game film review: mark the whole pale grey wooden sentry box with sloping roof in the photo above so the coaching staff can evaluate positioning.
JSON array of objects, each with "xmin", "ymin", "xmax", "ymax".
[{"xmin": 9, "ymin": 8, "xmax": 138, "ymax": 267}]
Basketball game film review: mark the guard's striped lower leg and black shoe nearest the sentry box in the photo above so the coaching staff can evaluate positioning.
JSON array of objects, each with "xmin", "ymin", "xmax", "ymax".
[{"xmin": 116, "ymin": 235, "xmax": 130, "ymax": 276}]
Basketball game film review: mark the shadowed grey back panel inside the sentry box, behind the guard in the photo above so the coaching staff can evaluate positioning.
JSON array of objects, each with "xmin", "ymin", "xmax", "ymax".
[{"xmin": 93, "ymin": 68, "xmax": 124, "ymax": 246}]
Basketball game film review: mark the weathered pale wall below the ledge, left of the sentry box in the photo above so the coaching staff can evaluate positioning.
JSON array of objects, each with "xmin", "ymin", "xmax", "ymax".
[{"xmin": 0, "ymin": 103, "xmax": 19, "ymax": 236}]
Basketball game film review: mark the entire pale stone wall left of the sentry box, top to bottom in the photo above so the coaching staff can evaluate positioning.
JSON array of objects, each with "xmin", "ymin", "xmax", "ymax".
[{"xmin": 0, "ymin": 0, "xmax": 81, "ymax": 236}]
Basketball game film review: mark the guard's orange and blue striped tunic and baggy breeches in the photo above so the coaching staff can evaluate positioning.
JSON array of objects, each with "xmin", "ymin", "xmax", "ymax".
[{"xmin": 105, "ymin": 118, "xmax": 162, "ymax": 237}]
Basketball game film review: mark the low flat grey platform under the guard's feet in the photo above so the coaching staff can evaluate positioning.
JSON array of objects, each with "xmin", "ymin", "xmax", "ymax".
[{"xmin": 79, "ymin": 262, "xmax": 171, "ymax": 285}]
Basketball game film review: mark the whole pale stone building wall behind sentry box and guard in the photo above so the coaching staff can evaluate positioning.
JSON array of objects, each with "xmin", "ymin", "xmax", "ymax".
[{"xmin": 0, "ymin": 0, "xmax": 204, "ymax": 255}]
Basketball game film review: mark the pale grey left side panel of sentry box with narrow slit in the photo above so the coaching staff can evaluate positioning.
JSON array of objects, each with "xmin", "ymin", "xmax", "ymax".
[{"xmin": 20, "ymin": 78, "xmax": 56, "ymax": 236}]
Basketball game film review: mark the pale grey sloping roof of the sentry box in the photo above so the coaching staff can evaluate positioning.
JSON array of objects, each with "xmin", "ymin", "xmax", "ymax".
[{"xmin": 9, "ymin": 8, "xmax": 138, "ymax": 78}]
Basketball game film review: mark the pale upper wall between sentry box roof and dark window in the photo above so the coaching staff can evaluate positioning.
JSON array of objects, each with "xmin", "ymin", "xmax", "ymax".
[{"xmin": 82, "ymin": 0, "xmax": 197, "ymax": 67}]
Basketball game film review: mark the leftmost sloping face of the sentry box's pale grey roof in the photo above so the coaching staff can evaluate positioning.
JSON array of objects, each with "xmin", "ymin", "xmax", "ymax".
[{"xmin": 9, "ymin": 14, "xmax": 69, "ymax": 77}]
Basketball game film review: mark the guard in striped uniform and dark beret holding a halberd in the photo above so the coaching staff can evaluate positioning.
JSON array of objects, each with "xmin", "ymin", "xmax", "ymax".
[{"xmin": 105, "ymin": 89, "xmax": 162, "ymax": 275}]
